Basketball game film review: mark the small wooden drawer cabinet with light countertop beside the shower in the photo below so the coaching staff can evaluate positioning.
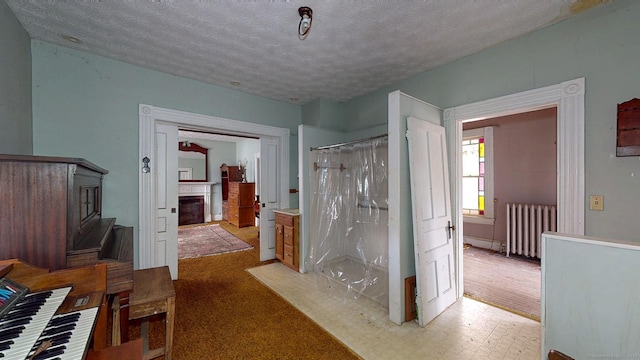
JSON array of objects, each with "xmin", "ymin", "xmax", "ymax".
[{"xmin": 274, "ymin": 210, "xmax": 300, "ymax": 271}]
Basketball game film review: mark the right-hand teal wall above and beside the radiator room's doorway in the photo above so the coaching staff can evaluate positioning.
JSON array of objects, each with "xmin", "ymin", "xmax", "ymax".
[{"xmin": 344, "ymin": 0, "xmax": 640, "ymax": 241}]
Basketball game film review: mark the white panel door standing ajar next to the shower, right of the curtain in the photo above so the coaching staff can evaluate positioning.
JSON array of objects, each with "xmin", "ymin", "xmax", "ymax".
[{"xmin": 407, "ymin": 117, "xmax": 456, "ymax": 326}]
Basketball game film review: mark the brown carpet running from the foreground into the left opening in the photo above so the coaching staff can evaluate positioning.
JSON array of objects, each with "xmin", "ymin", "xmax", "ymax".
[{"xmin": 130, "ymin": 222, "xmax": 359, "ymax": 360}]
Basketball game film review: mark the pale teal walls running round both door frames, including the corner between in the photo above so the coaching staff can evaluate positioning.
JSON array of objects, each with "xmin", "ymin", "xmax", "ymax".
[{"xmin": 22, "ymin": 0, "xmax": 640, "ymax": 250}]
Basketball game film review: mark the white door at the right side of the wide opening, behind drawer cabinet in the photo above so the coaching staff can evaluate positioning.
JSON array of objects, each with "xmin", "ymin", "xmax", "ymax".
[{"xmin": 259, "ymin": 138, "xmax": 280, "ymax": 261}]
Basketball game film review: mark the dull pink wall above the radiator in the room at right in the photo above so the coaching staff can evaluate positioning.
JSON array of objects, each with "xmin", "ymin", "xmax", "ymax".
[{"xmin": 463, "ymin": 108, "xmax": 557, "ymax": 242}]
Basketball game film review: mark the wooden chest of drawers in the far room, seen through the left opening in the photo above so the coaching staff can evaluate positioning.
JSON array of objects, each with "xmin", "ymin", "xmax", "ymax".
[{"xmin": 227, "ymin": 182, "xmax": 256, "ymax": 227}]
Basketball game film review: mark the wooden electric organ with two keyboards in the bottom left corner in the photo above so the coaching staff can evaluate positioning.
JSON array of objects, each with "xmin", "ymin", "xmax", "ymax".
[{"xmin": 0, "ymin": 259, "xmax": 108, "ymax": 354}]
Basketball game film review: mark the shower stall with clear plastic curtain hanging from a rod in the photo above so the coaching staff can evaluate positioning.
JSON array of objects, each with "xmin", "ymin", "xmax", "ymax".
[{"xmin": 309, "ymin": 135, "xmax": 389, "ymax": 309}]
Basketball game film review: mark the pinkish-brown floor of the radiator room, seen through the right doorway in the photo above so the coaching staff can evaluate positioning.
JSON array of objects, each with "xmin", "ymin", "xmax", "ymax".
[{"xmin": 464, "ymin": 246, "xmax": 541, "ymax": 321}]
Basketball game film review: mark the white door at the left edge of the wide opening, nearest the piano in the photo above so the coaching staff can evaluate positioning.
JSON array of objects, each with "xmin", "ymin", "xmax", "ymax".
[{"xmin": 157, "ymin": 123, "xmax": 178, "ymax": 279}]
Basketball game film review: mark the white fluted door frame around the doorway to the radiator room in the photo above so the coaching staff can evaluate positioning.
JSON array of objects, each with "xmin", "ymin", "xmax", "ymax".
[{"xmin": 444, "ymin": 78, "xmax": 585, "ymax": 297}]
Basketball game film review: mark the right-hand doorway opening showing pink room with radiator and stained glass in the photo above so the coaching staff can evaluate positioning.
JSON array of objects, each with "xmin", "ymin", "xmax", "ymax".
[{"xmin": 462, "ymin": 107, "xmax": 557, "ymax": 319}]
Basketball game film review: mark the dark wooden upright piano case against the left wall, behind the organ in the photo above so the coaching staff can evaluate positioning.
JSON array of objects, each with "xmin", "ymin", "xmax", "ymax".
[{"xmin": 0, "ymin": 155, "xmax": 115, "ymax": 270}]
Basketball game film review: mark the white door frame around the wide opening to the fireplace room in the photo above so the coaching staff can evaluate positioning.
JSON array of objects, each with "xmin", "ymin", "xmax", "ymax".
[{"xmin": 138, "ymin": 104, "xmax": 290, "ymax": 269}]
